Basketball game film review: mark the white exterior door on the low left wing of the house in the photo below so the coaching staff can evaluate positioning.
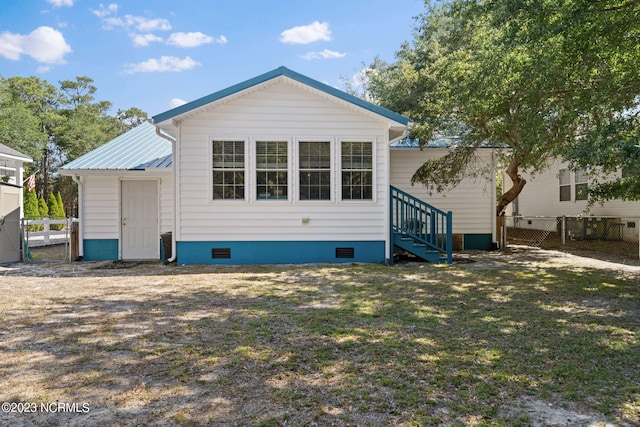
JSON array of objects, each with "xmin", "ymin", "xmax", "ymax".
[{"xmin": 120, "ymin": 180, "xmax": 160, "ymax": 260}]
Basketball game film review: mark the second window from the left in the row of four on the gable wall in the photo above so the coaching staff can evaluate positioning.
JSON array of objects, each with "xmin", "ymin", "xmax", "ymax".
[{"xmin": 256, "ymin": 141, "xmax": 289, "ymax": 200}]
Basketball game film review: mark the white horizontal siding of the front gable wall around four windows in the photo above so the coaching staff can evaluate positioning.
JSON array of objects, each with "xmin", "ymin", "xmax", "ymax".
[{"xmin": 176, "ymin": 80, "xmax": 389, "ymax": 241}]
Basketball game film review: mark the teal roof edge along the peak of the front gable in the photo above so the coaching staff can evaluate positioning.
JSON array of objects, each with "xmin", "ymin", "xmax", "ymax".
[{"xmin": 152, "ymin": 67, "xmax": 411, "ymax": 125}]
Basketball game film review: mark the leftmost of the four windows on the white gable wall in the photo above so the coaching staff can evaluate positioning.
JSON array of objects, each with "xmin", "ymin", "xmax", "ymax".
[{"xmin": 212, "ymin": 141, "xmax": 245, "ymax": 200}]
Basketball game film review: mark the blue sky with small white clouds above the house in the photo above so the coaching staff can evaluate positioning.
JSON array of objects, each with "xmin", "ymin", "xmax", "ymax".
[{"xmin": 0, "ymin": 0, "xmax": 425, "ymax": 116}]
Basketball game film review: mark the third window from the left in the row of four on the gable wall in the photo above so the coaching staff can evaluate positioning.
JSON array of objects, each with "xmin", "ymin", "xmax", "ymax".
[{"xmin": 298, "ymin": 141, "xmax": 331, "ymax": 200}]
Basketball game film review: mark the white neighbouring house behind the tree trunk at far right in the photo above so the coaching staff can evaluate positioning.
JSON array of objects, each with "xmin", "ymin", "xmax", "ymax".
[{"xmin": 506, "ymin": 160, "xmax": 640, "ymax": 241}]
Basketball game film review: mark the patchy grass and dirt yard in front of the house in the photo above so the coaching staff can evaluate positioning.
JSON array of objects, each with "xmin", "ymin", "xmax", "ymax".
[{"xmin": 0, "ymin": 249, "xmax": 640, "ymax": 427}]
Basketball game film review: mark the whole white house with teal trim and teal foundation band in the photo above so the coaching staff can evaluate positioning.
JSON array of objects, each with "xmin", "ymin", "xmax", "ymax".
[{"xmin": 60, "ymin": 67, "xmax": 495, "ymax": 264}]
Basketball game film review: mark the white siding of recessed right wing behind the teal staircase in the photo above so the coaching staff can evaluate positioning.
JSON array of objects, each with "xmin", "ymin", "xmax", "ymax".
[{"xmin": 390, "ymin": 148, "xmax": 496, "ymax": 234}]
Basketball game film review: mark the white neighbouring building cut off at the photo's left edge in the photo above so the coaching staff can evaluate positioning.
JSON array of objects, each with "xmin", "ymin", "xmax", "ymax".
[{"xmin": 0, "ymin": 144, "xmax": 33, "ymax": 263}]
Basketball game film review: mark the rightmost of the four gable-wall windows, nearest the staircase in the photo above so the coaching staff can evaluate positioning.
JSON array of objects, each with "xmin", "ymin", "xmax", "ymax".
[{"xmin": 341, "ymin": 141, "xmax": 373, "ymax": 200}]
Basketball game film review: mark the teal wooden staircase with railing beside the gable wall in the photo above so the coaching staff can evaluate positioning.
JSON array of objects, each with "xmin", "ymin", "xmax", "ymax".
[{"xmin": 391, "ymin": 186, "xmax": 453, "ymax": 264}]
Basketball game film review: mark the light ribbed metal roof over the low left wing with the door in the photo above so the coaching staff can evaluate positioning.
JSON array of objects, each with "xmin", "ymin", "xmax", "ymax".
[{"xmin": 60, "ymin": 122, "xmax": 171, "ymax": 171}]
